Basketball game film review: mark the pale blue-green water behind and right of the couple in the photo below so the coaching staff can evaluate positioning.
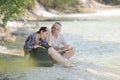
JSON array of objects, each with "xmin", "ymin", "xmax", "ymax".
[{"xmin": 26, "ymin": 16, "xmax": 120, "ymax": 71}]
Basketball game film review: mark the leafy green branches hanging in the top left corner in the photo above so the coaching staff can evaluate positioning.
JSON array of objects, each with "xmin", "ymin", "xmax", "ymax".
[{"xmin": 0, "ymin": 0, "xmax": 35, "ymax": 27}]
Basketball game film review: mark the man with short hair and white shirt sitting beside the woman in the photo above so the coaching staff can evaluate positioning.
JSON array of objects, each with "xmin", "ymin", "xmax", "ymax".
[{"xmin": 50, "ymin": 22, "xmax": 74, "ymax": 59}]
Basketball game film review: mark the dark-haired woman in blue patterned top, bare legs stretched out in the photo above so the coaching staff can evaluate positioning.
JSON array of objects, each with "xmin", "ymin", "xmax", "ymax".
[{"xmin": 24, "ymin": 27, "xmax": 74, "ymax": 67}]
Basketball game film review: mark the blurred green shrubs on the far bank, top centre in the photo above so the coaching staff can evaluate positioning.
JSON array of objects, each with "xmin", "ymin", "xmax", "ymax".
[{"xmin": 39, "ymin": 0, "xmax": 79, "ymax": 11}]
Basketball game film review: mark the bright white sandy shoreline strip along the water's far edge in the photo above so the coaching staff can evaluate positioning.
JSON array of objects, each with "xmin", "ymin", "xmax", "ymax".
[{"xmin": 7, "ymin": 9, "xmax": 120, "ymax": 27}]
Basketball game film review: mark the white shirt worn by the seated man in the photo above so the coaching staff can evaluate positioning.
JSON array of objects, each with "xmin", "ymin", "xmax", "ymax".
[{"xmin": 50, "ymin": 33, "xmax": 67, "ymax": 47}]
